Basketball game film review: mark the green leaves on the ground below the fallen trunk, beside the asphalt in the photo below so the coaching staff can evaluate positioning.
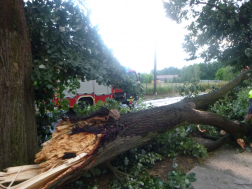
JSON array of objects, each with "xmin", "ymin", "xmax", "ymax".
[{"xmin": 108, "ymin": 127, "xmax": 203, "ymax": 189}]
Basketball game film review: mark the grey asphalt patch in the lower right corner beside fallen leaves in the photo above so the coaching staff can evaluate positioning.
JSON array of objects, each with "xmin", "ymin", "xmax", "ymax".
[{"xmin": 189, "ymin": 145, "xmax": 252, "ymax": 189}]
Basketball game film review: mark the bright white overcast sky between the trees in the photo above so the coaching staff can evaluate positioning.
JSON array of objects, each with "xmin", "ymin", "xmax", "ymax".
[{"xmin": 89, "ymin": 0, "xmax": 200, "ymax": 73}]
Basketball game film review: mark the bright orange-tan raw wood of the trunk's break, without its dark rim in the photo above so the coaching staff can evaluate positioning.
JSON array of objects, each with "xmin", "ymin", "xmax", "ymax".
[{"xmin": 35, "ymin": 118, "xmax": 101, "ymax": 173}]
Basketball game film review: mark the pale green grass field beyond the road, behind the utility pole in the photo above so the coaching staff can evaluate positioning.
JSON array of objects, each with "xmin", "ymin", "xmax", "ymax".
[{"xmin": 142, "ymin": 81, "xmax": 227, "ymax": 95}]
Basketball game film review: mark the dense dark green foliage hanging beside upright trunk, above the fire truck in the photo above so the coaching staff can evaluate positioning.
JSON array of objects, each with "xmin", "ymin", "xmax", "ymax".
[{"xmin": 24, "ymin": 0, "xmax": 137, "ymax": 142}]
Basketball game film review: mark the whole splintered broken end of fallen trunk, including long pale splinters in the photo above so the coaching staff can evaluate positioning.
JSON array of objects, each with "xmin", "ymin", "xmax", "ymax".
[{"xmin": 0, "ymin": 108, "xmax": 120, "ymax": 189}]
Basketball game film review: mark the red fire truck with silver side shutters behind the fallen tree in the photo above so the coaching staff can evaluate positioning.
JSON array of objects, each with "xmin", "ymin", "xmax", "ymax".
[{"xmin": 54, "ymin": 69, "xmax": 140, "ymax": 108}]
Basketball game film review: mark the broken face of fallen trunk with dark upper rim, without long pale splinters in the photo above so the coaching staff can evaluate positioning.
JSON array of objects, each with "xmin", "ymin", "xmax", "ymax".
[{"xmin": 35, "ymin": 108, "xmax": 120, "ymax": 173}]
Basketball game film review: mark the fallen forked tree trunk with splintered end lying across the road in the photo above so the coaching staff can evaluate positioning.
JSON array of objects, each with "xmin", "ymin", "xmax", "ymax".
[{"xmin": 0, "ymin": 71, "xmax": 251, "ymax": 189}]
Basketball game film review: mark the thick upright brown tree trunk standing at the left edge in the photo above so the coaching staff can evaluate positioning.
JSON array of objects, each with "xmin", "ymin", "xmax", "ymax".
[{"xmin": 0, "ymin": 0, "xmax": 38, "ymax": 169}]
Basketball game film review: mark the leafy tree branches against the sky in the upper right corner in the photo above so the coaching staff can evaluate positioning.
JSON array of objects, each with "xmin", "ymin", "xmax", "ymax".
[{"xmin": 164, "ymin": 0, "xmax": 252, "ymax": 71}]
